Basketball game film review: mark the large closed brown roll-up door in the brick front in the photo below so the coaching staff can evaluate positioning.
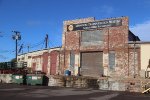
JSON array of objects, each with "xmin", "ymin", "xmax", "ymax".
[{"xmin": 81, "ymin": 52, "xmax": 103, "ymax": 77}]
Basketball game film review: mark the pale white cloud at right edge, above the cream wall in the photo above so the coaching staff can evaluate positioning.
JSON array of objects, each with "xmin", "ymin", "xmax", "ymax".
[{"xmin": 130, "ymin": 20, "xmax": 150, "ymax": 41}]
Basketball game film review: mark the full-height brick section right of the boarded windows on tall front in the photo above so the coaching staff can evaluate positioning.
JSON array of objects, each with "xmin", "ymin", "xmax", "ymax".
[{"xmin": 106, "ymin": 17, "xmax": 129, "ymax": 77}]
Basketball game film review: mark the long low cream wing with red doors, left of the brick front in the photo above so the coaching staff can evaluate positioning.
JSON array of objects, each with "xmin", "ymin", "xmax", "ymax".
[{"xmin": 18, "ymin": 48, "xmax": 61, "ymax": 75}]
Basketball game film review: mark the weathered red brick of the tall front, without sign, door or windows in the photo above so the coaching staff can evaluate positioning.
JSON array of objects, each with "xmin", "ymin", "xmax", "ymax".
[{"xmin": 62, "ymin": 17, "xmax": 138, "ymax": 77}]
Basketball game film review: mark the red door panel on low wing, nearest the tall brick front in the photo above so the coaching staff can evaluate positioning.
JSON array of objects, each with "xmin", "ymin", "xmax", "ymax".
[{"xmin": 50, "ymin": 51, "xmax": 59, "ymax": 75}]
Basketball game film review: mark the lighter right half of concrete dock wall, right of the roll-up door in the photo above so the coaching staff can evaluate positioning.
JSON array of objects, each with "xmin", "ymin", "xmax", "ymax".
[{"xmin": 98, "ymin": 78, "xmax": 150, "ymax": 92}]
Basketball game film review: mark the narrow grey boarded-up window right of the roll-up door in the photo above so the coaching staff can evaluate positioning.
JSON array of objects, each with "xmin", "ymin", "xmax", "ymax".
[{"xmin": 109, "ymin": 51, "xmax": 115, "ymax": 69}]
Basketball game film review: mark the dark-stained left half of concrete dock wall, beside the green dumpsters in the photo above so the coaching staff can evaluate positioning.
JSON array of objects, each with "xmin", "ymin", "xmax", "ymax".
[{"xmin": 48, "ymin": 75, "xmax": 98, "ymax": 88}]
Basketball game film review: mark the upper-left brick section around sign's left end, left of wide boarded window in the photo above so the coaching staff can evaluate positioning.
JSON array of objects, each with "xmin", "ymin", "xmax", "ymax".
[{"xmin": 62, "ymin": 17, "xmax": 94, "ymax": 50}]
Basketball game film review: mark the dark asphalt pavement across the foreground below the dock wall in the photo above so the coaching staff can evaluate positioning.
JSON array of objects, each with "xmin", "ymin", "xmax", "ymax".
[{"xmin": 0, "ymin": 84, "xmax": 150, "ymax": 100}]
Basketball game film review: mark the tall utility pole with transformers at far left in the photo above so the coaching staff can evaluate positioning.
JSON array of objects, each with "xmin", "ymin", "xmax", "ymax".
[{"xmin": 12, "ymin": 31, "xmax": 21, "ymax": 62}]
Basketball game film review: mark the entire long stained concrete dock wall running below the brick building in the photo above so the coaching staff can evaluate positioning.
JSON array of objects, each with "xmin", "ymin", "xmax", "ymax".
[{"xmin": 48, "ymin": 75, "xmax": 150, "ymax": 92}]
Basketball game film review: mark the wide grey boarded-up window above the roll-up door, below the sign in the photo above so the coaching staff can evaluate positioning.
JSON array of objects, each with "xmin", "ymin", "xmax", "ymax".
[{"xmin": 81, "ymin": 30, "xmax": 104, "ymax": 46}]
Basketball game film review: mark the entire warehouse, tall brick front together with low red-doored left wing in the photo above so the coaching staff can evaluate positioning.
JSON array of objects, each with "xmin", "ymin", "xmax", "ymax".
[{"xmin": 18, "ymin": 17, "xmax": 150, "ymax": 77}]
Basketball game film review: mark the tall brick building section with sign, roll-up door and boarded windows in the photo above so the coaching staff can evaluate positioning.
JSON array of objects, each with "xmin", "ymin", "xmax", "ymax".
[{"xmin": 62, "ymin": 17, "xmax": 140, "ymax": 77}]
